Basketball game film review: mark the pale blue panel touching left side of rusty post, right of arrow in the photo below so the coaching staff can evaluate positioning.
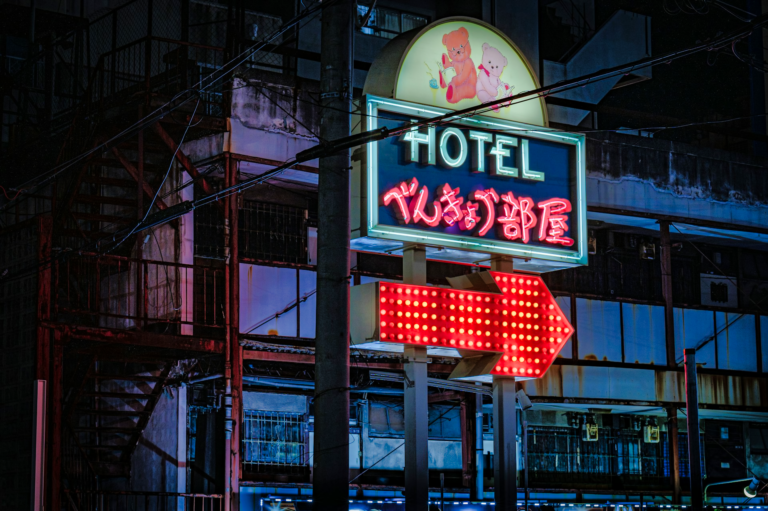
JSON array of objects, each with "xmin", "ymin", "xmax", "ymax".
[{"xmin": 621, "ymin": 303, "xmax": 667, "ymax": 365}]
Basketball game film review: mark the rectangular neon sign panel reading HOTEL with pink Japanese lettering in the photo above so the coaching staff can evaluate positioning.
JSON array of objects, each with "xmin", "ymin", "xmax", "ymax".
[{"xmin": 353, "ymin": 97, "xmax": 587, "ymax": 271}]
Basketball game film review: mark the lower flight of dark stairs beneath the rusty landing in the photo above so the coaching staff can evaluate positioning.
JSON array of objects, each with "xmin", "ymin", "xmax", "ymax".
[{"xmin": 64, "ymin": 357, "xmax": 173, "ymax": 477}]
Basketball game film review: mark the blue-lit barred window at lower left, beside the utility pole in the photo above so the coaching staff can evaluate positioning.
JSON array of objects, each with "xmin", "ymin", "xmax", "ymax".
[{"xmin": 243, "ymin": 410, "xmax": 307, "ymax": 473}]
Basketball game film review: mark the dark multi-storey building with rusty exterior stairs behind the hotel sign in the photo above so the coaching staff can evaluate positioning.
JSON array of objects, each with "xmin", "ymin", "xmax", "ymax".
[{"xmin": 0, "ymin": 0, "xmax": 768, "ymax": 510}]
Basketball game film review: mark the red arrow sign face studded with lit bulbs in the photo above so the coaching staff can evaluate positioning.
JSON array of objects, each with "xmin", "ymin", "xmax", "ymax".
[{"xmin": 368, "ymin": 272, "xmax": 573, "ymax": 378}]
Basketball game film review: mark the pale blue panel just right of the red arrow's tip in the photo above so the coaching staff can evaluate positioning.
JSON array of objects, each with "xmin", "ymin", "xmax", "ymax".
[{"xmin": 576, "ymin": 298, "xmax": 621, "ymax": 362}]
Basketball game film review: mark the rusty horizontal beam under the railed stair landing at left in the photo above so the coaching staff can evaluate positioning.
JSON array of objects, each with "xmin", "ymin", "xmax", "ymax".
[{"xmin": 43, "ymin": 322, "xmax": 224, "ymax": 354}]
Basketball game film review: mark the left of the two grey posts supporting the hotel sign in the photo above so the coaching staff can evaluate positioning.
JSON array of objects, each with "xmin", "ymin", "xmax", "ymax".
[{"xmin": 403, "ymin": 245, "xmax": 429, "ymax": 511}]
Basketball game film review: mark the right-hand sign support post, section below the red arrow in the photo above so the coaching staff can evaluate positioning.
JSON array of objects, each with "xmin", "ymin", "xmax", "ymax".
[{"xmin": 493, "ymin": 376, "xmax": 517, "ymax": 511}]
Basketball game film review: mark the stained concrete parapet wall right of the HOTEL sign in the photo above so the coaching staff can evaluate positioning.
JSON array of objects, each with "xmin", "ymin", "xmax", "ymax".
[{"xmin": 587, "ymin": 133, "xmax": 768, "ymax": 227}]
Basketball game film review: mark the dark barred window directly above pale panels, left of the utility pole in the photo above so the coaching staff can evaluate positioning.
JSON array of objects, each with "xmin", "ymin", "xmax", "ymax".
[{"xmin": 239, "ymin": 201, "xmax": 307, "ymax": 263}]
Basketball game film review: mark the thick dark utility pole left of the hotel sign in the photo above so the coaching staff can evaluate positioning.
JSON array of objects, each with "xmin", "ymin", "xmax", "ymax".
[{"xmin": 312, "ymin": 0, "xmax": 354, "ymax": 511}]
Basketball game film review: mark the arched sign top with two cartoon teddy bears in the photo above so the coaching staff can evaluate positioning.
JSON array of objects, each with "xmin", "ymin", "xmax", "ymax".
[{"xmin": 364, "ymin": 18, "xmax": 548, "ymax": 126}]
